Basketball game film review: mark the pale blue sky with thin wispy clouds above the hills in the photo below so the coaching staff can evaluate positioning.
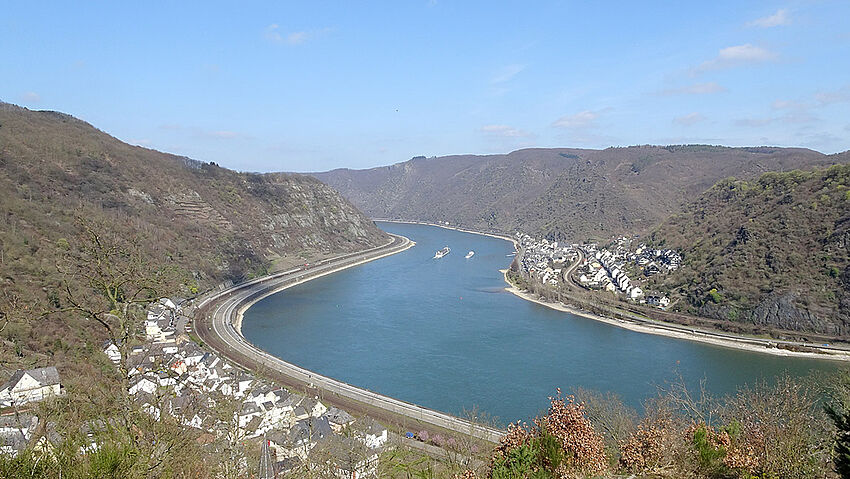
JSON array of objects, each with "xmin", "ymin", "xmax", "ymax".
[{"xmin": 0, "ymin": 0, "xmax": 850, "ymax": 171}]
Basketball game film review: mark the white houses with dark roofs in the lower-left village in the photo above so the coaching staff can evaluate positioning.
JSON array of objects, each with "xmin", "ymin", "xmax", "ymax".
[{"xmin": 0, "ymin": 299, "xmax": 388, "ymax": 478}]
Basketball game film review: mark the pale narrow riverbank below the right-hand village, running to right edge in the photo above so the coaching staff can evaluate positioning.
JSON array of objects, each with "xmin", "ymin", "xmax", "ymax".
[{"xmin": 500, "ymin": 269, "xmax": 850, "ymax": 361}]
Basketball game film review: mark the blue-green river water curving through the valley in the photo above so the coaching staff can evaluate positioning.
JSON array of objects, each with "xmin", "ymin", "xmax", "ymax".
[{"xmin": 242, "ymin": 223, "xmax": 838, "ymax": 423}]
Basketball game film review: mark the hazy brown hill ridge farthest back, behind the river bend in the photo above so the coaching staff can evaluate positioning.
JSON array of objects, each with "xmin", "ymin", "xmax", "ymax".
[{"xmin": 313, "ymin": 145, "xmax": 846, "ymax": 241}]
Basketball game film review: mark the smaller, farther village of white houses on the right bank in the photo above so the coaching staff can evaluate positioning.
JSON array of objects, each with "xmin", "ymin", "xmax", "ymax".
[{"xmin": 515, "ymin": 233, "xmax": 682, "ymax": 309}]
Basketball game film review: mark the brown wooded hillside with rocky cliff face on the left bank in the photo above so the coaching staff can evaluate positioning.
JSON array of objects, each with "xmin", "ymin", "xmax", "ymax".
[{"xmin": 0, "ymin": 103, "xmax": 388, "ymax": 365}]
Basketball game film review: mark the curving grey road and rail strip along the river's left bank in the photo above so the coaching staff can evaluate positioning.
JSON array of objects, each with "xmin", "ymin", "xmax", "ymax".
[{"xmin": 195, "ymin": 235, "xmax": 504, "ymax": 443}]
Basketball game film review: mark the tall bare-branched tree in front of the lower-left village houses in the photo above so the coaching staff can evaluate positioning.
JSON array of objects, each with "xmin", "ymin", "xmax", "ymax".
[{"xmin": 51, "ymin": 216, "xmax": 185, "ymax": 474}]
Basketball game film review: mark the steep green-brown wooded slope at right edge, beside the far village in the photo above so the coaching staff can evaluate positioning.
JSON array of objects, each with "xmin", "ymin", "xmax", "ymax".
[{"xmin": 651, "ymin": 165, "xmax": 850, "ymax": 336}]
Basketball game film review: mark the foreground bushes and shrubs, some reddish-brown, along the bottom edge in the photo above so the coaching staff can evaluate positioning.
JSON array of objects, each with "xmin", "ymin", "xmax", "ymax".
[{"xmin": 0, "ymin": 372, "xmax": 850, "ymax": 479}]
